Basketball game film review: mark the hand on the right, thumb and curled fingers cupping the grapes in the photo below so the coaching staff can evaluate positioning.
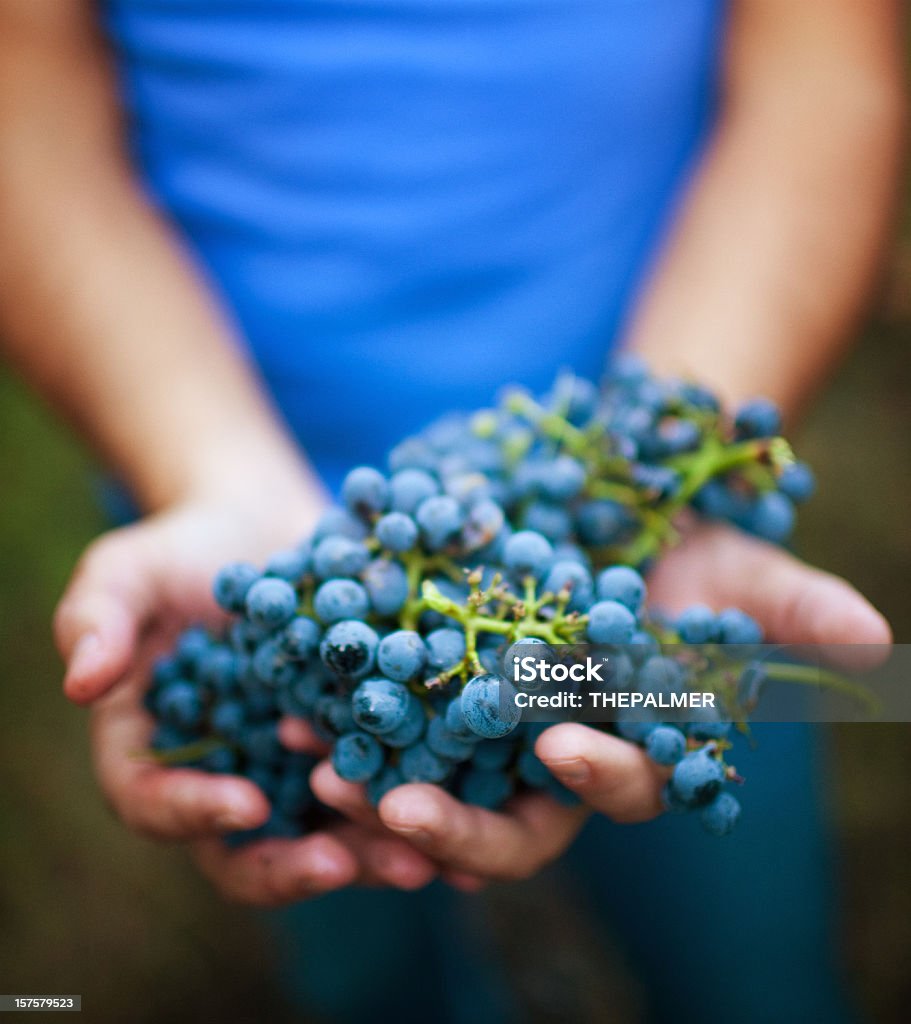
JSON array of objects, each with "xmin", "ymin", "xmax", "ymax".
[{"xmin": 327, "ymin": 525, "xmax": 892, "ymax": 885}]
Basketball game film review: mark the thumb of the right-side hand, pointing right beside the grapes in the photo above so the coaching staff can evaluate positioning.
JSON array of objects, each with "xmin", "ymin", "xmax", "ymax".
[{"xmin": 655, "ymin": 527, "xmax": 892, "ymax": 668}]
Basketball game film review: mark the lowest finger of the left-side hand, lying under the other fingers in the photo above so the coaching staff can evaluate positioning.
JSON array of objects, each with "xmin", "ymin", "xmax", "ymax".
[{"xmin": 192, "ymin": 833, "xmax": 359, "ymax": 906}]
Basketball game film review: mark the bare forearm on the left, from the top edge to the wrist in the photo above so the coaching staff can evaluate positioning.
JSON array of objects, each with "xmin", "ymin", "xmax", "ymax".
[{"xmin": 0, "ymin": 2, "xmax": 323, "ymax": 508}]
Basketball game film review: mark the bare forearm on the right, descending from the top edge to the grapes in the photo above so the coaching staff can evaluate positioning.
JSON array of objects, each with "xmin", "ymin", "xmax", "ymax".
[{"xmin": 628, "ymin": 0, "xmax": 903, "ymax": 413}]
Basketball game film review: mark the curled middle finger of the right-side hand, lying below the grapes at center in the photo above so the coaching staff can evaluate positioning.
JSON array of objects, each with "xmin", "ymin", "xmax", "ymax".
[{"xmin": 379, "ymin": 784, "xmax": 585, "ymax": 879}]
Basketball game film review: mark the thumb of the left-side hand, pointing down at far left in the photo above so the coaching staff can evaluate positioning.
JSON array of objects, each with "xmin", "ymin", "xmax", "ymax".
[{"xmin": 53, "ymin": 528, "xmax": 155, "ymax": 703}]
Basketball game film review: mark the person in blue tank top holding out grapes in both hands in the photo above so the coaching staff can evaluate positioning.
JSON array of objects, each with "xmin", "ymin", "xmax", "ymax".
[{"xmin": 0, "ymin": 0, "xmax": 904, "ymax": 1022}]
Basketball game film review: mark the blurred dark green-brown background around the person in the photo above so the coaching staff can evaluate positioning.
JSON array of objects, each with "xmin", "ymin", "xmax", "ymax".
[{"xmin": 0, "ymin": 148, "xmax": 911, "ymax": 1024}]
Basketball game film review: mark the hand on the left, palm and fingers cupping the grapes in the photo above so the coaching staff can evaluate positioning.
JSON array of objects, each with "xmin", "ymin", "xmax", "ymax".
[{"xmin": 54, "ymin": 488, "xmax": 435, "ymax": 905}]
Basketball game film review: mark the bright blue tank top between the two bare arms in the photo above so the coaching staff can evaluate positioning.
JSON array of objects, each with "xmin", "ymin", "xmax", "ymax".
[{"xmin": 104, "ymin": 0, "xmax": 724, "ymax": 477}]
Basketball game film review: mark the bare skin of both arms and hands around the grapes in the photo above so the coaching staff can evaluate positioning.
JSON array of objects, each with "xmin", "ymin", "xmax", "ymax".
[{"xmin": 0, "ymin": 0, "xmax": 904, "ymax": 904}]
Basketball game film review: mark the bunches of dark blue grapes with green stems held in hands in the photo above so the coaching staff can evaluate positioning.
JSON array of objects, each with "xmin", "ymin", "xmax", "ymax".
[{"xmin": 145, "ymin": 359, "xmax": 813, "ymax": 836}]
